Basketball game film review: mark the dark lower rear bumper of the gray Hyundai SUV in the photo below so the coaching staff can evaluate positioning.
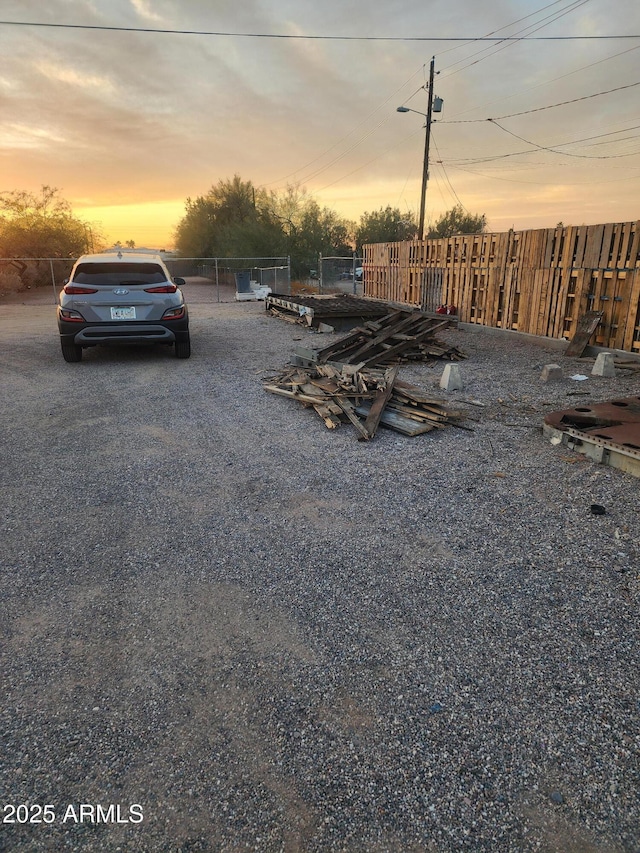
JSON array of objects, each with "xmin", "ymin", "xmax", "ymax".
[{"xmin": 58, "ymin": 317, "xmax": 189, "ymax": 347}]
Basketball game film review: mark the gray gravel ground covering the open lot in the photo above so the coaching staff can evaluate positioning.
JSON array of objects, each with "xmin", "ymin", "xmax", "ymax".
[{"xmin": 0, "ymin": 284, "xmax": 640, "ymax": 853}]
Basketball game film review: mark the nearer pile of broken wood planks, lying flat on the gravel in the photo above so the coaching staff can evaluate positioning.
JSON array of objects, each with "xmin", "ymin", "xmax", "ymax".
[{"xmin": 264, "ymin": 364, "xmax": 463, "ymax": 441}]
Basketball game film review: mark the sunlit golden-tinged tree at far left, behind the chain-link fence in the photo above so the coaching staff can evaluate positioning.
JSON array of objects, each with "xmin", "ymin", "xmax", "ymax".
[{"xmin": 0, "ymin": 185, "xmax": 101, "ymax": 258}]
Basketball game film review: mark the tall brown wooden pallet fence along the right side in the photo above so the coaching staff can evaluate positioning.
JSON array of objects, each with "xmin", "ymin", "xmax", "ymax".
[{"xmin": 363, "ymin": 221, "xmax": 640, "ymax": 352}]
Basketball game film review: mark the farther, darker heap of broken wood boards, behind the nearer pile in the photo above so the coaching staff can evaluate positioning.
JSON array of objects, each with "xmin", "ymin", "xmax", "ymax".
[{"xmin": 306, "ymin": 309, "xmax": 466, "ymax": 367}]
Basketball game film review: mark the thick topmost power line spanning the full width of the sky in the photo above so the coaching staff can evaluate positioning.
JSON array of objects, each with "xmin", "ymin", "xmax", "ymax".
[{"xmin": 0, "ymin": 21, "xmax": 640, "ymax": 43}]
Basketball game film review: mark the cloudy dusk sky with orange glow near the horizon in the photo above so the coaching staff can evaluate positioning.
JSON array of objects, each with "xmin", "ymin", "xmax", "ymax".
[{"xmin": 0, "ymin": 0, "xmax": 640, "ymax": 248}]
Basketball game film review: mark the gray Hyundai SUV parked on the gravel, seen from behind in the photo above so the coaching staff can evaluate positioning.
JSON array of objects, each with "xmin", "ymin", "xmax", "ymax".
[{"xmin": 58, "ymin": 252, "xmax": 191, "ymax": 361}]
